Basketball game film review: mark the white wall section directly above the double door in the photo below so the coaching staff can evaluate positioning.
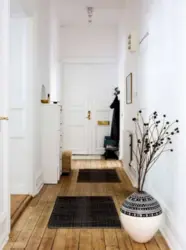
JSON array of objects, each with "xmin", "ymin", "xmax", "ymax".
[{"xmin": 61, "ymin": 25, "xmax": 118, "ymax": 58}]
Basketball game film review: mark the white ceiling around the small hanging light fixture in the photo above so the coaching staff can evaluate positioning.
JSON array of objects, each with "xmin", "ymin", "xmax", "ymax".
[{"xmin": 53, "ymin": 0, "xmax": 125, "ymax": 26}]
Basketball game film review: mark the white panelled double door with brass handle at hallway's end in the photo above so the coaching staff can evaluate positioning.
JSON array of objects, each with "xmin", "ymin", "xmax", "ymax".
[{"xmin": 62, "ymin": 64, "xmax": 117, "ymax": 155}]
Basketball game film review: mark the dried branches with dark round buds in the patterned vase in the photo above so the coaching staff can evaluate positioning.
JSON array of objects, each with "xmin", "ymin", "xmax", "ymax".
[{"xmin": 132, "ymin": 110, "xmax": 179, "ymax": 192}]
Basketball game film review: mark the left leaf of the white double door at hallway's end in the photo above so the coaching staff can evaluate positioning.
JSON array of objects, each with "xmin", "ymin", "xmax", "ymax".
[{"xmin": 62, "ymin": 64, "xmax": 89, "ymax": 154}]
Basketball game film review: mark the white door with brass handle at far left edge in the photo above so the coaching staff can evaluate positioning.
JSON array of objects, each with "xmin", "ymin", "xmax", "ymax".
[{"xmin": 0, "ymin": 0, "xmax": 10, "ymax": 249}]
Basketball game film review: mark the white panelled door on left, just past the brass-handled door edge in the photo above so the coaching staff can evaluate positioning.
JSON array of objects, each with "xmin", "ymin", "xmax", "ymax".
[{"xmin": 9, "ymin": 18, "xmax": 34, "ymax": 194}]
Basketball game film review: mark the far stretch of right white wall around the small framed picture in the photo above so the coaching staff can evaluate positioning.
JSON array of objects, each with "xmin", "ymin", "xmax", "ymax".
[{"xmin": 118, "ymin": 0, "xmax": 140, "ymax": 176}]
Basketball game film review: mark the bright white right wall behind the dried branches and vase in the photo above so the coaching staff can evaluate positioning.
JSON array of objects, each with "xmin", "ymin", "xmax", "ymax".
[{"xmin": 122, "ymin": 0, "xmax": 186, "ymax": 250}]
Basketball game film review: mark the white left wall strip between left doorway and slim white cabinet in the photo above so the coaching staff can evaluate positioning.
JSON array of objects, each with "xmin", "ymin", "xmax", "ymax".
[{"xmin": 33, "ymin": 0, "xmax": 50, "ymax": 194}]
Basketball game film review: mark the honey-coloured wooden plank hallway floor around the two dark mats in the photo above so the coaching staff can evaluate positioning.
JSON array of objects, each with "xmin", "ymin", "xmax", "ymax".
[{"xmin": 4, "ymin": 160, "xmax": 169, "ymax": 250}]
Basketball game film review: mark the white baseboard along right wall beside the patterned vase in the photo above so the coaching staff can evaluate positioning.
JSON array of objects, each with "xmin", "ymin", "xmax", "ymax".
[{"xmin": 146, "ymin": 184, "xmax": 185, "ymax": 250}]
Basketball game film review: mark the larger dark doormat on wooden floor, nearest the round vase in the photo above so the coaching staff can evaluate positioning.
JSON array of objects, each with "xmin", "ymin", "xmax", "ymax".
[{"xmin": 48, "ymin": 196, "xmax": 121, "ymax": 229}]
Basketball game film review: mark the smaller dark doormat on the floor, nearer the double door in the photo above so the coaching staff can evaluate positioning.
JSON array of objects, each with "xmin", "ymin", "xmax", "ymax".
[{"xmin": 77, "ymin": 169, "xmax": 120, "ymax": 183}]
